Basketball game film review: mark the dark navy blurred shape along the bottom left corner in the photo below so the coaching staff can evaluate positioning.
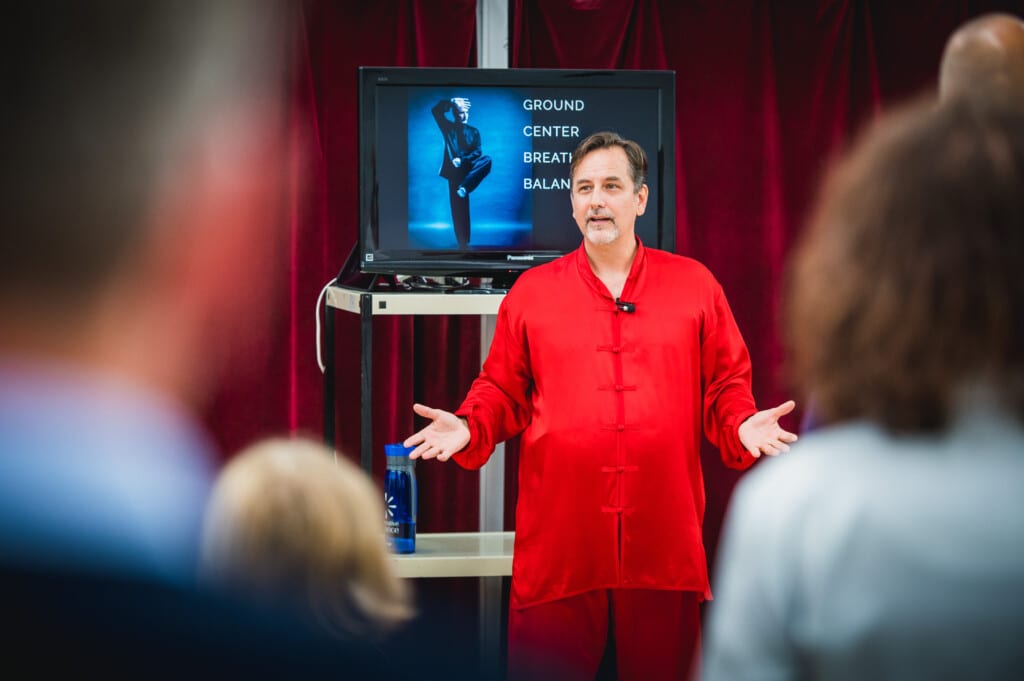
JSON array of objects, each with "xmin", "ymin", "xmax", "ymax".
[{"xmin": 0, "ymin": 565, "xmax": 402, "ymax": 679}]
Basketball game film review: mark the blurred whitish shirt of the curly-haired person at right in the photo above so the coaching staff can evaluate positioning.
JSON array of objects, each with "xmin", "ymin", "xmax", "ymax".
[{"xmin": 703, "ymin": 410, "xmax": 1024, "ymax": 681}]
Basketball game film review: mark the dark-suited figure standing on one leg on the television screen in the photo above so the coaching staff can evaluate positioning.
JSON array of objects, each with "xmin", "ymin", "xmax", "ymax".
[{"xmin": 430, "ymin": 97, "xmax": 490, "ymax": 249}]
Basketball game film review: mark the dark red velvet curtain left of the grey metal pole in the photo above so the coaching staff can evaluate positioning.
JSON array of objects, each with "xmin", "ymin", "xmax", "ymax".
[{"xmin": 206, "ymin": 0, "xmax": 480, "ymax": 531}]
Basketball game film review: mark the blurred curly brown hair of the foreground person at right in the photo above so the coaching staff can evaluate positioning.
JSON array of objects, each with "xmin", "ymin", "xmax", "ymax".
[{"xmin": 784, "ymin": 96, "xmax": 1024, "ymax": 432}]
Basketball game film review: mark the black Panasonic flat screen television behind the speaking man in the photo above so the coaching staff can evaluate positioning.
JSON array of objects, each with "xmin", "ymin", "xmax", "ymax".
[{"xmin": 353, "ymin": 67, "xmax": 676, "ymax": 284}]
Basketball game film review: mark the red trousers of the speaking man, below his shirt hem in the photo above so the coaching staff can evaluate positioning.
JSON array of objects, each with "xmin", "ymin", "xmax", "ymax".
[{"xmin": 508, "ymin": 589, "xmax": 700, "ymax": 681}]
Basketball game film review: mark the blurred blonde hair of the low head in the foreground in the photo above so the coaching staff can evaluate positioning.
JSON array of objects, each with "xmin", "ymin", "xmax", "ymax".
[{"xmin": 201, "ymin": 438, "xmax": 413, "ymax": 636}]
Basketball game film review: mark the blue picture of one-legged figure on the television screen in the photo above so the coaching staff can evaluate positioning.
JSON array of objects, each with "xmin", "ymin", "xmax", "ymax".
[{"xmin": 408, "ymin": 87, "xmax": 532, "ymax": 250}]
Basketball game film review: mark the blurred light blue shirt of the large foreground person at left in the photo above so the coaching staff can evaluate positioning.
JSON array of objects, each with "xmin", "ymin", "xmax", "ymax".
[{"xmin": 0, "ymin": 364, "xmax": 215, "ymax": 583}]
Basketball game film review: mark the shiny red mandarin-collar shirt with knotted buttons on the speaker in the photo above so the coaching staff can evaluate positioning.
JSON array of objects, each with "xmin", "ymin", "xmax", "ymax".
[{"xmin": 455, "ymin": 242, "xmax": 757, "ymax": 607}]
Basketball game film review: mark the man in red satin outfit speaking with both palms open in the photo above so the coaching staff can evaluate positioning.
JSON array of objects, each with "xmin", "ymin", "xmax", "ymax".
[{"xmin": 406, "ymin": 132, "xmax": 797, "ymax": 680}]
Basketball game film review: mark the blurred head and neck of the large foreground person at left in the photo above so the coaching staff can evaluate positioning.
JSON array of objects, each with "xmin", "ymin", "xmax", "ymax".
[{"xmin": 0, "ymin": 0, "xmax": 287, "ymax": 405}]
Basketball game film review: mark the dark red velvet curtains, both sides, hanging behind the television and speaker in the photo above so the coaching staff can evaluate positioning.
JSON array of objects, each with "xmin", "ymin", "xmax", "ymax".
[{"xmin": 201, "ymin": 0, "xmax": 1024, "ymax": 557}]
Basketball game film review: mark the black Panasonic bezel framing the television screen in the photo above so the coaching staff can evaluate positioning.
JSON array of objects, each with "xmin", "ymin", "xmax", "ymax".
[{"xmin": 354, "ymin": 67, "xmax": 676, "ymax": 278}]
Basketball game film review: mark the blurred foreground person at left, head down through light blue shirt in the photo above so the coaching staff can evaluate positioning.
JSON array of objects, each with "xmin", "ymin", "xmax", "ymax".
[{"xmin": 0, "ymin": 0, "xmax": 287, "ymax": 581}]
